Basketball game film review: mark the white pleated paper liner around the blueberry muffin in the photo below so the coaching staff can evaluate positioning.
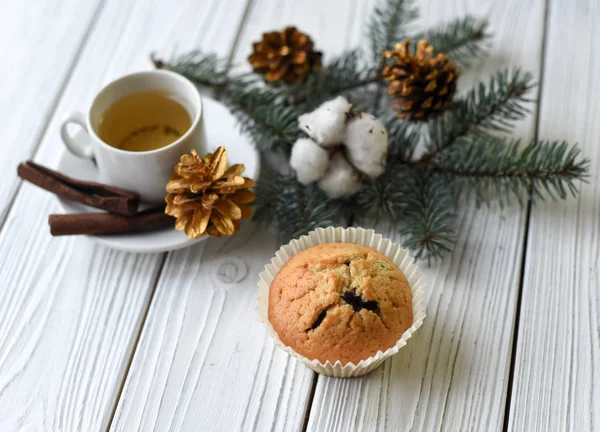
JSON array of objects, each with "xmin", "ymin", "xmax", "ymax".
[{"xmin": 256, "ymin": 227, "xmax": 426, "ymax": 378}]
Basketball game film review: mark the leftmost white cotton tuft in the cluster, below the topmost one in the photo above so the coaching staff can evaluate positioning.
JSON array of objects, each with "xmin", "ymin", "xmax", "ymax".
[{"xmin": 290, "ymin": 138, "xmax": 329, "ymax": 184}]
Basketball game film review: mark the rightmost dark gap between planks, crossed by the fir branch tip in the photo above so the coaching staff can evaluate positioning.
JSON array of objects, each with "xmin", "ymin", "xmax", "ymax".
[{"xmin": 502, "ymin": 0, "xmax": 550, "ymax": 432}]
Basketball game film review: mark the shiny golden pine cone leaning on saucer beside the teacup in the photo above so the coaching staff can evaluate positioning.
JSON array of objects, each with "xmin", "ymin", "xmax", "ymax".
[{"xmin": 165, "ymin": 147, "xmax": 256, "ymax": 238}]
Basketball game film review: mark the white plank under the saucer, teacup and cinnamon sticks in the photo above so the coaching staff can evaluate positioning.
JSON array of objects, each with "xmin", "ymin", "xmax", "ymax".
[{"xmin": 0, "ymin": 0, "xmax": 244, "ymax": 431}]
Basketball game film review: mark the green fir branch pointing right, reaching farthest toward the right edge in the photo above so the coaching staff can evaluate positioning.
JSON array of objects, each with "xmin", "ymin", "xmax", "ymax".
[{"xmin": 433, "ymin": 137, "xmax": 589, "ymax": 205}]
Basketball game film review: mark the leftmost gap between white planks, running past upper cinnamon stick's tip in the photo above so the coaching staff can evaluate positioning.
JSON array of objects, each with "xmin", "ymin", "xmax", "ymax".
[{"xmin": 0, "ymin": 0, "xmax": 107, "ymax": 232}]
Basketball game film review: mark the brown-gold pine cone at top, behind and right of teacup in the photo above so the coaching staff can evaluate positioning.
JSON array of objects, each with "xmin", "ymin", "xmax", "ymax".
[{"xmin": 248, "ymin": 27, "xmax": 322, "ymax": 84}]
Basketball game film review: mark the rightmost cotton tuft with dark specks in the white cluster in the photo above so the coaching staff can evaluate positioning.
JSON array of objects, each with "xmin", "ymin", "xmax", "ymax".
[{"xmin": 344, "ymin": 114, "xmax": 388, "ymax": 177}]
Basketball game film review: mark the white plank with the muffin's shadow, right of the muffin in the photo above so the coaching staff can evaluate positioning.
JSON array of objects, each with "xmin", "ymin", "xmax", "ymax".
[{"xmin": 308, "ymin": 0, "xmax": 544, "ymax": 432}]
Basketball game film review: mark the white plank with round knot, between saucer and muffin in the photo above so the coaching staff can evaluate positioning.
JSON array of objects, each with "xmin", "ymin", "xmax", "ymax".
[{"xmin": 111, "ymin": 0, "xmax": 365, "ymax": 431}]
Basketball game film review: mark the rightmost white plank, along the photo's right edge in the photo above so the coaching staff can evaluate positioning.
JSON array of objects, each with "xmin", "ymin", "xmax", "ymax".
[{"xmin": 509, "ymin": 0, "xmax": 600, "ymax": 431}]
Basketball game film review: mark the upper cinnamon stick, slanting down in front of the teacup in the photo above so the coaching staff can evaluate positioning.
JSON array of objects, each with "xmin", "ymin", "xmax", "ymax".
[{"xmin": 17, "ymin": 161, "xmax": 140, "ymax": 216}]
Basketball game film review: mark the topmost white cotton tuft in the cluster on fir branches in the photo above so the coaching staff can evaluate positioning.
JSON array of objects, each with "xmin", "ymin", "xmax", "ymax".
[{"xmin": 298, "ymin": 96, "xmax": 352, "ymax": 147}]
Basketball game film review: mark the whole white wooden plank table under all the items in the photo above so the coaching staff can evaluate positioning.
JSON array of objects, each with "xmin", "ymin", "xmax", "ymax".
[{"xmin": 0, "ymin": 0, "xmax": 600, "ymax": 432}]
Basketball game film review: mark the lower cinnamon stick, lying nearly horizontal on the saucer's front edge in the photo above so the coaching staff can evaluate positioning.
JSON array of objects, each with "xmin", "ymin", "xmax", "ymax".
[{"xmin": 48, "ymin": 206, "xmax": 175, "ymax": 236}]
